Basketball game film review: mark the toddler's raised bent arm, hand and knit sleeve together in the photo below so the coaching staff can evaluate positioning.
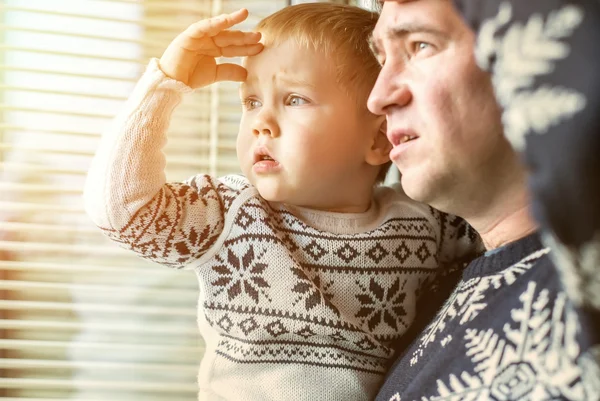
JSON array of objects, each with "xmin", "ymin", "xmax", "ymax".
[{"xmin": 84, "ymin": 10, "xmax": 260, "ymax": 267}]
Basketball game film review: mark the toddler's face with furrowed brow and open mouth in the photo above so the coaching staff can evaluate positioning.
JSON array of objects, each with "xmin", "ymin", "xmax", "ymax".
[{"xmin": 237, "ymin": 41, "xmax": 381, "ymax": 210}]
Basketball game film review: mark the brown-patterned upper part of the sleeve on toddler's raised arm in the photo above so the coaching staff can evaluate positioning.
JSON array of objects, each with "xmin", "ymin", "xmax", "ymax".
[{"xmin": 95, "ymin": 175, "xmax": 239, "ymax": 268}]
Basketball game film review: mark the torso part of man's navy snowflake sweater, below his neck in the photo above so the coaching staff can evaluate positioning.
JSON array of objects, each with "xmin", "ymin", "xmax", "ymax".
[{"xmin": 377, "ymin": 234, "xmax": 600, "ymax": 401}]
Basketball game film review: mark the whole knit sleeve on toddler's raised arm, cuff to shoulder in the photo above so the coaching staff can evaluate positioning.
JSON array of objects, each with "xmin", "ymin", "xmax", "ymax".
[{"xmin": 84, "ymin": 60, "xmax": 237, "ymax": 268}]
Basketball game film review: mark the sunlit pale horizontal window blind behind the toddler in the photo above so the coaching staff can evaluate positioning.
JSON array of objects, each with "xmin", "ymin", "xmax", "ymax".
[{"xmin": 0, "ymin": 0, "xmax": 364, "ymax": 401}]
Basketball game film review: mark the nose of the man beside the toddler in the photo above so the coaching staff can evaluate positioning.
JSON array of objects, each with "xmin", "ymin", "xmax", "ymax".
[{"xmin": 367, "ymin": 66, "xmax": 412, "ymax": 115}]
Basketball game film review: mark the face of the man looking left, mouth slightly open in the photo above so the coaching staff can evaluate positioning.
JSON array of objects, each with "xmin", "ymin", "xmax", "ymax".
[{"xmin": 368, "ymin": 0, "xmax": 512, "ymax": 213}]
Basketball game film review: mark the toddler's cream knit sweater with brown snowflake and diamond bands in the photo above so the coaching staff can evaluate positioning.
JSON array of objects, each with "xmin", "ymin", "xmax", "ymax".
[{"xmin": 85, "ymin": 60, "xmax": 479, "ymax": 401}]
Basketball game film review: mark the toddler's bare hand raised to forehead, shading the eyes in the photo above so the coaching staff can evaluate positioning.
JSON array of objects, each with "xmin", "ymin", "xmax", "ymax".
[{"xmin": 159, "ymin": 9, "xmax": 263, "ymax": 88}]
